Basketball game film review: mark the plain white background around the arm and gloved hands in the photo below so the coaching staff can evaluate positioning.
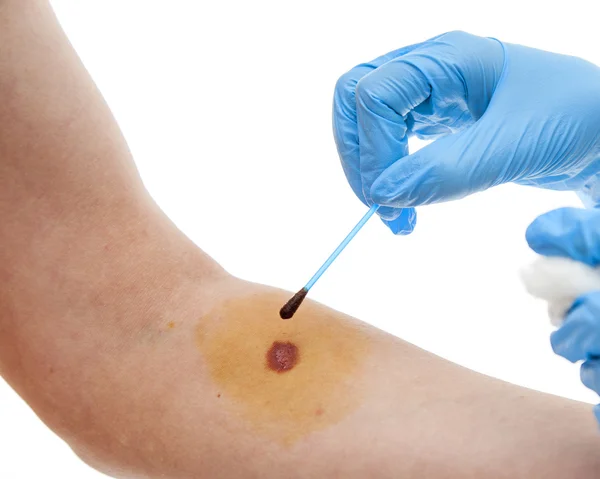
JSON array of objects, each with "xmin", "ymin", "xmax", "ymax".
[{"xmin": 0, "ymin": 0, "xmax": 600, "ymax": 479}]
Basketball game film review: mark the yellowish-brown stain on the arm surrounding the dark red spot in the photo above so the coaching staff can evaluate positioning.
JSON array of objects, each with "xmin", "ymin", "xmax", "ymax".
[{"xmin": 196, "ymin": 290, "xmax": 372, "ymax": 445}]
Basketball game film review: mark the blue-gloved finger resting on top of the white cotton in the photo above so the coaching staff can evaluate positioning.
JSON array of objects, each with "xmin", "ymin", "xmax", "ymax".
[{"xmin": 526, "ymin": 208, "xmax": 600, "ymax": 266}]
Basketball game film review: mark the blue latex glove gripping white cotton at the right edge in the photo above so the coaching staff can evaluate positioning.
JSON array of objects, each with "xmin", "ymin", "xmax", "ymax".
[{"xmin": 527, "ymin": 208, "xmax": 600, "ymax": 422}]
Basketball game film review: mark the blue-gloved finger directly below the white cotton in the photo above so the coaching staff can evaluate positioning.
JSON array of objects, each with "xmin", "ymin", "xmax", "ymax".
[{"xmin": 550, "ymin": 291, "xmax": 600, "ymax": 363}]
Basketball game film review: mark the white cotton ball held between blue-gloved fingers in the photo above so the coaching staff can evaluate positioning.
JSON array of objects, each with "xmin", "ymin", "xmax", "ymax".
[{"xmin": 521, "ymin": 257, "xmax": 600, "ymax": 326}]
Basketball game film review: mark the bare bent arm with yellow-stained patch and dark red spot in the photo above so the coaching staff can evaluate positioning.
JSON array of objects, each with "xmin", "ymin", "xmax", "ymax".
[{"xmin": 0, "ymin": 0, "xmax": 600, "ymax": 479}]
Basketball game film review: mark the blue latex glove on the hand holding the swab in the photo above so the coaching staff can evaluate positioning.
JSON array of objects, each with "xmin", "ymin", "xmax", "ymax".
[{"xmin": 333, "ymin": 32, "xmax": 600, "ymax": 233}]
